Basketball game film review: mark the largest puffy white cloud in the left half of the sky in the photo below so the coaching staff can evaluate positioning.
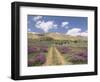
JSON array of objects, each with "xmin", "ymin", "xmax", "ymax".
[{"xmin": 35, "ymin": 21, "xmax": 57, "ymax": 32}]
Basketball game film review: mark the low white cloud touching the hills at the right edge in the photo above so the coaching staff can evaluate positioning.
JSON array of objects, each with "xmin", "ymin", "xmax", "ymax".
[{"xmin": 66, "ymin": 28, "xmax": 87, "ymax": 36}]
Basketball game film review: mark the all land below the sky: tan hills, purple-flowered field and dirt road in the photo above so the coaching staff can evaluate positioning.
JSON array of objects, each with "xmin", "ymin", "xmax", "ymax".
[{"xmin": 27, "ymin": 33, "xmax": 88, "ymax": 66}]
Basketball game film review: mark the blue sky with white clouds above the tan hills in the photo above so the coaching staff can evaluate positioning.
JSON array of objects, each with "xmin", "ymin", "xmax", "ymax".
[{"xmin": 27, "ymin": 15, "xmax": 88, "ymax": 36}]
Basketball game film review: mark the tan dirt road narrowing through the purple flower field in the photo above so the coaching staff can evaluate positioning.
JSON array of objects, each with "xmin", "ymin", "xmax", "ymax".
[{"xmin": 44, "ymin": 46, "xmax": 69, "ymax": 66}]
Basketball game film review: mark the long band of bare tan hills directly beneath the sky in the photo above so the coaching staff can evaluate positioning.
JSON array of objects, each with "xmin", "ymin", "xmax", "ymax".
[{"xmin": 28, "ymin": 32, "xmax": 87, "ymax": 40}]
